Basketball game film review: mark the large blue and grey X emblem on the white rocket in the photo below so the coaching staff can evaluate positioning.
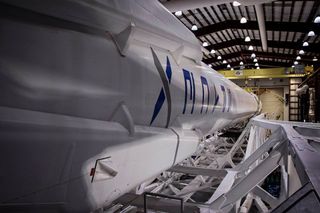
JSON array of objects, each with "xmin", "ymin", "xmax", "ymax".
[{"xmin": 150, "ymin": 48, "xmax": 172, "ymax": 128}]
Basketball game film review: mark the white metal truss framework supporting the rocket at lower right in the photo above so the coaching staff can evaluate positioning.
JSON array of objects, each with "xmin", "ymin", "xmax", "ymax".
[{"xmin": 106, "ymin": 115, "xmax": 320, "ymax": 213}]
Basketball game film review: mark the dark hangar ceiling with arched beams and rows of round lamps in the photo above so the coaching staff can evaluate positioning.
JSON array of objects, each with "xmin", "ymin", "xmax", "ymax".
[{"xmin": 161, "ymin": 0, "xmax": 320, "ymax": 70}]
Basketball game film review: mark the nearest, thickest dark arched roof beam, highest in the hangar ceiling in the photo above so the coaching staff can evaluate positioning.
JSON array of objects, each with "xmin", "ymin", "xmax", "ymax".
[{"xmin": 194, "ymin": 20, "xmax": 320, "ymax": 37}]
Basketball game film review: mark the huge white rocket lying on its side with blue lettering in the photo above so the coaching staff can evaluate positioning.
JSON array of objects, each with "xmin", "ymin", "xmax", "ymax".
[{"xmin": 0, "ymin": 0, "xmax": 259, "ymax": 212}]
